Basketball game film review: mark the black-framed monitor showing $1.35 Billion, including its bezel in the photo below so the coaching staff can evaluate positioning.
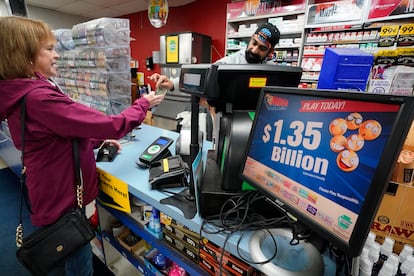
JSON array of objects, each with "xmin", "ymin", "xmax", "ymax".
[{"xmin": 241, "ymin": 87, "xmax": 413, "ymax": 256}]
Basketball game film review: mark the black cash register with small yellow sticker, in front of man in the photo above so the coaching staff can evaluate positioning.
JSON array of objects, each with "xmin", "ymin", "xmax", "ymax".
[{"xmin": 179, "ymin": 64, "xmax": 302, "ymax": 218}]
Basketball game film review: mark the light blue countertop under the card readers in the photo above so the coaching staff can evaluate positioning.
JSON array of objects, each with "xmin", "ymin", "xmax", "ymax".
[{"xmin": 97, "ymin": 125, "xmax": 335, "ymax": 275}]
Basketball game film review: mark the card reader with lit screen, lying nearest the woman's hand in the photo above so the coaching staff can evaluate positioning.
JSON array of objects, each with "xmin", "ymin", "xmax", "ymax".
[{"xmin": 136, "ymin": 136, "xmax": 174, "ymax": 168}]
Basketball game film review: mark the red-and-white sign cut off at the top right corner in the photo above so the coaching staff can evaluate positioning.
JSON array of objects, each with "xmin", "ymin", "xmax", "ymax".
[{"xmin": 368, "ymin": 0, "xmax": 414, "ymax": 20}]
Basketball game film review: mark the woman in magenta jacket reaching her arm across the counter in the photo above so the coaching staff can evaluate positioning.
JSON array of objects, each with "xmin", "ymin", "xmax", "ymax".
[{"xmin": 0, "ymin": 16, "xmax": 164, "ymax": 276}]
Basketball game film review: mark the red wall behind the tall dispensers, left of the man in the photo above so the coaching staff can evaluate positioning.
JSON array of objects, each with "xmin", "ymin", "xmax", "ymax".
[{"xmin": 123, "ymin": 0, "xmax": 231, "ymax": 75}]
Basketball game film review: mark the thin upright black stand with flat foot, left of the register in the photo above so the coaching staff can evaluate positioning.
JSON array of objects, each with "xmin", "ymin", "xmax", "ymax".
[{"xmin": 160, "ymin": 94, "xmax": 200, "ymax": 219}]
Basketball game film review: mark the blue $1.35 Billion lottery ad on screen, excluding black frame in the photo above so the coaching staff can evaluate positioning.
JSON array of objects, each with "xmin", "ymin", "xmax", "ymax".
[{"xmin": 243, "ymin": 94, "xmax": 399, "ymax": 241}]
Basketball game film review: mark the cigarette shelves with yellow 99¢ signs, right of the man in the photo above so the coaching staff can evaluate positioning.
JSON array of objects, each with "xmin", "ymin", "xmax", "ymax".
[{"xmin": 300, "ymin": 1, "xmax": 414, "ymax": 88}]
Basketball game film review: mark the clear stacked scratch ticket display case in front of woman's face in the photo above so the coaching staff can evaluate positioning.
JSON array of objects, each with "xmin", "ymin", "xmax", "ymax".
[{"xmin": 54, "ymin": 17, "xmax": 131, "ymax": 114}]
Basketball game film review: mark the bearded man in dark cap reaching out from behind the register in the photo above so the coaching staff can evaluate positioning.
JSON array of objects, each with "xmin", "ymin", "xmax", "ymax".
[{"xmin": 149, "ymin": 23, "xmax": 280, "ymax": 91}]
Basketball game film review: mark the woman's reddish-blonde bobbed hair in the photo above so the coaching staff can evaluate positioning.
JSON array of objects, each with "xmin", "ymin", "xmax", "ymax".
[{"xmin": 0, "ymin": 16, "xmax": 56, "ymax": 79}]
